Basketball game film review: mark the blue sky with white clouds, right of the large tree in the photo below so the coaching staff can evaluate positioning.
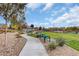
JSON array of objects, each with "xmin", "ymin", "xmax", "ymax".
[{"xmin": 25, "ymin": 3, "xmax": 79, "ymax": 27}]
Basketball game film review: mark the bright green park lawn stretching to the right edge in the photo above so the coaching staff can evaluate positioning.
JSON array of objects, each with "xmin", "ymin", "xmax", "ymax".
[{"xmin": 43, "ymin": 32, "xmax": 79, "ymax": 51}]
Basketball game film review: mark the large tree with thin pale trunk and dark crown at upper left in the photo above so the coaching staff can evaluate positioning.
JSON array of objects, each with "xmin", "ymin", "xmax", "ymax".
[{"xmin": 0, "ymin": 3, "xmax": 25, "ymax": 45}]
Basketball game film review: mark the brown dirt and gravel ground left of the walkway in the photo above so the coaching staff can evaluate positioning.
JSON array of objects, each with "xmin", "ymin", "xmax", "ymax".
[{"xmin": 0, "ymin": 33, "xmax": 26, "ymax": 56}]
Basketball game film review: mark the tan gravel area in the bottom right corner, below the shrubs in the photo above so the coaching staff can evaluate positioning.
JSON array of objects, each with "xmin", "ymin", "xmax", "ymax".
[{"xmin": 48, "ymin": 45, "xmax": 79, "ymax": 56}]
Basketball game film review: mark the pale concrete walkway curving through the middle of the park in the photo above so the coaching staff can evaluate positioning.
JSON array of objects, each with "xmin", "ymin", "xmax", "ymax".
[{"xmin": 19, "ymin": 34, "xmax": 48, "ymax": 56}]
